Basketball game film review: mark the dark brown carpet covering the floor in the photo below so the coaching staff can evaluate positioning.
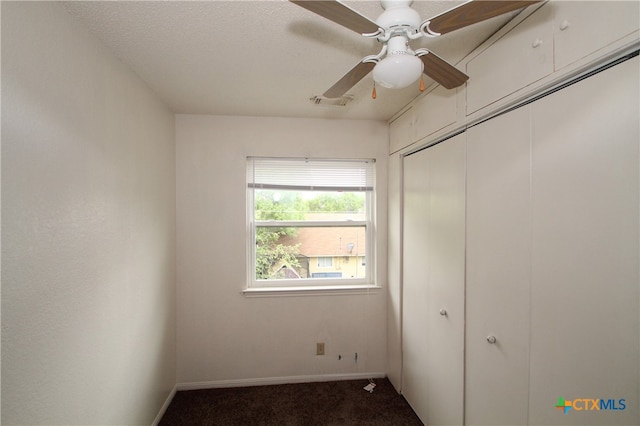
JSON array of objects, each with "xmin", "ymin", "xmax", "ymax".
[{"xmin": 160, "ymin": 379, "xmax": 422, "ymax": 426}]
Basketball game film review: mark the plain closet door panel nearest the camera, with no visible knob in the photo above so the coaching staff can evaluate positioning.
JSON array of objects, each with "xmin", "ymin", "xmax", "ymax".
[{"xmin": 529, "ymin": 57, "xmax": 640, "ymax": 425}]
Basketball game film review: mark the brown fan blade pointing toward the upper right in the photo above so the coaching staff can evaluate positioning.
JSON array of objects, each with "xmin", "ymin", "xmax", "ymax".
[{"xmin": 421, "ymin": 0, "xmax": 541, "ymax": 35}]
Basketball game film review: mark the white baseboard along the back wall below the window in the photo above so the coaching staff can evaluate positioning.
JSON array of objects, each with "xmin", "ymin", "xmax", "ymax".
[{"xmin": 176, "ymin": 373, "xmax": 386, "ymax": 391}]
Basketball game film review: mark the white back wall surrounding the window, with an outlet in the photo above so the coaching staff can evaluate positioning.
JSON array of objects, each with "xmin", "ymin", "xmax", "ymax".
[{"xmin": 176, "ymin": 115, "xmax": 388, "ymax": 385}]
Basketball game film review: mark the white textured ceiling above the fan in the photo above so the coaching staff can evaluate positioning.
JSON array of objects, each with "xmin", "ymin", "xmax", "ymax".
[{"xmin": 65, "ymin": 0, "xmax": 514, "ymax": 120}]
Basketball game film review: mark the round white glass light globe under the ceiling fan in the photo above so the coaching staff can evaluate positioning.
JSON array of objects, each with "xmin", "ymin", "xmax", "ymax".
[{"xmin": 373, "ymin": 53, "xmax": 424, "ymax": 89}]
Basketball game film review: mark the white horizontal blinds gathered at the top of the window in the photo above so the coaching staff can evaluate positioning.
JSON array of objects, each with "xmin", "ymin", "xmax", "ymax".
[{"xmin": 247, "ymin": 157, "xmax": 375, "ymax": 191}]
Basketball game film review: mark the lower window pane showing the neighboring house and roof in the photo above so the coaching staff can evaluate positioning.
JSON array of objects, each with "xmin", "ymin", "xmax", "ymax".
[{"xmin": 256, "ymin": 226, "xmax": 366, "ymax": 284}]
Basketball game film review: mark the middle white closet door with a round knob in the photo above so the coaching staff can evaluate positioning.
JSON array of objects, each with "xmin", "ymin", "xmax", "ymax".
[{"xmin": 465, "ymin": 106, "xmax": 531, "ymax": 425}]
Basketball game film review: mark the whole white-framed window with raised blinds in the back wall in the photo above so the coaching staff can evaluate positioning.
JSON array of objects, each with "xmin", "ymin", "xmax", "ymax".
[{"xmin": 247, "ymin": 157, "xmax": 375, "ymax": 289}]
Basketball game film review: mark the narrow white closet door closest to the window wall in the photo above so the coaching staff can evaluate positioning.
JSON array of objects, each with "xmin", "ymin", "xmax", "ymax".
[{"xmin": 402, "ymin": 134, "xmax": 466, "ymax": 425}]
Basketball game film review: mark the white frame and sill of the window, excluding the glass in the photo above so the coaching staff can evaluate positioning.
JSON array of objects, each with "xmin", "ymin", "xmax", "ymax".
[{"xmin": 243, "ymin": 157, "xmax": 379, "ymax": 294}]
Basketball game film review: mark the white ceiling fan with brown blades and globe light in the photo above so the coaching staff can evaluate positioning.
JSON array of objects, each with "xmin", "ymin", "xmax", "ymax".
[{"xmin": 290, "ymin": 0, "xmax": 541, "ymax": 99}]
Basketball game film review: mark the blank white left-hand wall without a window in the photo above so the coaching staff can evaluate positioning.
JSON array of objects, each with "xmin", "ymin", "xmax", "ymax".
[{"xmin": 2, "ymin": 2, "xmax": 176, "ymax": 424}]
